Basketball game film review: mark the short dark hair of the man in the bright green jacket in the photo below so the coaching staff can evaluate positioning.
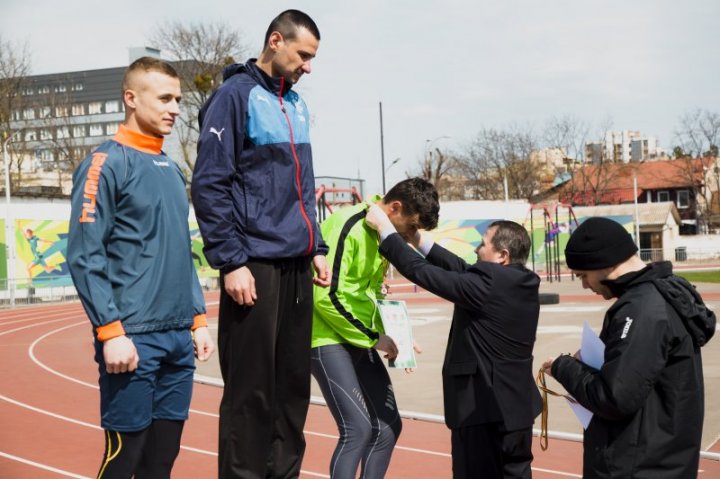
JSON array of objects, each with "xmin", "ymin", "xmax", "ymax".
[{"xmin": 383, "ymin": 178, "xmax": 440, "ymax": 230}]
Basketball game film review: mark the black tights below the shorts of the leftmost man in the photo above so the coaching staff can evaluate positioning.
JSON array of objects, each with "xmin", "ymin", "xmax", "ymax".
[{"xmin": 97, "ymin": 419, "xmax": 185, "ymax": 479}]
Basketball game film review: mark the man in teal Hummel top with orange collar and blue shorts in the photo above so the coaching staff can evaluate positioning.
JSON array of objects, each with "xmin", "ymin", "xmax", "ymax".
[{"xmin": 68, "ymin": 57, "xmax": 214, "ymax": 479}]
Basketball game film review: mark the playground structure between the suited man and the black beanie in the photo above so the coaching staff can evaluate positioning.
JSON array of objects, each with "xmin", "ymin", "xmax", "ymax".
[{"xmin": 525, "ymin": 202, "xmax": 579, "ymax": 282}]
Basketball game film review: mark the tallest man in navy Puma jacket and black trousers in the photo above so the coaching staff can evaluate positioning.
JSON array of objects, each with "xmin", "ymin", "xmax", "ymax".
[{"xmin": 192, "ymin": 10, "xmax": 329, "ymax": 478}]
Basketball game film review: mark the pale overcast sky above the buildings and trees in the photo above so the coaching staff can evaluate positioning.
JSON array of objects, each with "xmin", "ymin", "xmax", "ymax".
[{"xmin": 0, "ymin": 0, "xmax": 720, "ymax": 193}]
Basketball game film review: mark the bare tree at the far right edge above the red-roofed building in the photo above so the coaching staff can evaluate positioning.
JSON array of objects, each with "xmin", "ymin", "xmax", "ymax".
[{"xmin": 673, "ymin": 108, "xmax": 720, "ymax": 158}]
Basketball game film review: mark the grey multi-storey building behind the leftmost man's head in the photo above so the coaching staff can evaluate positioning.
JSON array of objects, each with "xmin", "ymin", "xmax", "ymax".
[{"xmin": 4, "ymin": 47, "xmax": 179, "ymax": 196}]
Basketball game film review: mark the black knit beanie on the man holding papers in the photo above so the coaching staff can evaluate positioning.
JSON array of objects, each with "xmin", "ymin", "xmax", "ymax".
[{"xmin": 565, "ymin": 217, "xmax": 637, "ymax": 271}]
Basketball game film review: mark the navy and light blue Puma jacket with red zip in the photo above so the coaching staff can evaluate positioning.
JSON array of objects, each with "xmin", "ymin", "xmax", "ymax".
[{"xmin": 192, "ymin": 59, "xmax": 327, "ymax": 274}]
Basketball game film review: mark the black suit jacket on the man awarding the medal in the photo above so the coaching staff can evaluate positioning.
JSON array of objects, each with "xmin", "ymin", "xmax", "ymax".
[{"xmin": 380, "ymin": 234, "xmax": 542, "ymax": 431}]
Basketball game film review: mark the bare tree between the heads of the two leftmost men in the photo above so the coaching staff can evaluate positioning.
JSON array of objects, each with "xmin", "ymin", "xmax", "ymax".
[{"xmin": 150, "ymin": 21, "xmax": 248, "ymax": 173}]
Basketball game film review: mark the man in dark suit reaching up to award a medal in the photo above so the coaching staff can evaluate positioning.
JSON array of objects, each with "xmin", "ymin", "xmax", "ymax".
[{"xmin": 366, "ymin": 207, "xmax": 542, "ymax": 478}]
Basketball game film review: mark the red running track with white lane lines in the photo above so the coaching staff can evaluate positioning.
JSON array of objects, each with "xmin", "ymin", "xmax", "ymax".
[{"xmin": 0, "ymin": 303, "xmax": 720, "ymax": 479}]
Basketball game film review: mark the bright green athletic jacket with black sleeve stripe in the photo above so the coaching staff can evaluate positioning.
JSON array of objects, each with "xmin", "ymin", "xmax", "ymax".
[{"xmin": 312, "ymin": 197, "xmax": 387, "ymax": 348}]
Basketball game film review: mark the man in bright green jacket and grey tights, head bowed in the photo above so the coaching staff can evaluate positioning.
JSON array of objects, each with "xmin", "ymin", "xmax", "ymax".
[{"xmin": 311, "ymin": 178, "xmax": 440, "ymax": 478}]
